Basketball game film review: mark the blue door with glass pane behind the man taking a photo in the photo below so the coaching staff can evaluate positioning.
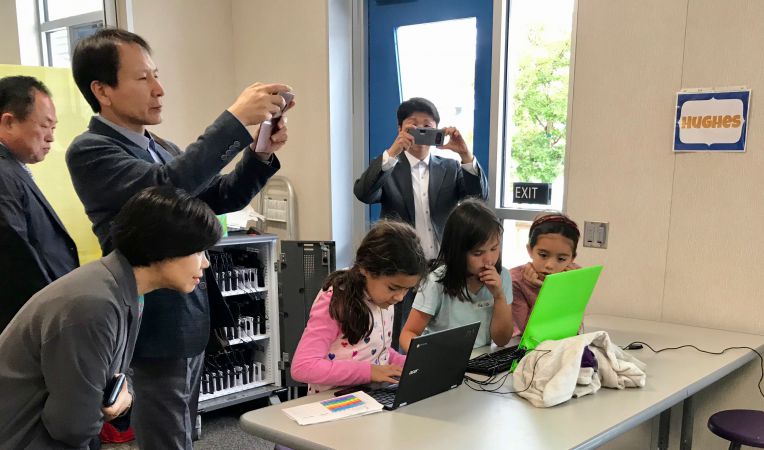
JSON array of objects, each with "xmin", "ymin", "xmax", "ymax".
[{"xmin": 366, "ymin": 0, "xmax": 493, "ymax": 221}]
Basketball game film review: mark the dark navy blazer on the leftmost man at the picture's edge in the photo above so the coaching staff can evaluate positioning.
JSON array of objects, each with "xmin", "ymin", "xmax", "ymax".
[{"xmin": 0, "ymin": 144, "xmax": 79, "ymax": 332}]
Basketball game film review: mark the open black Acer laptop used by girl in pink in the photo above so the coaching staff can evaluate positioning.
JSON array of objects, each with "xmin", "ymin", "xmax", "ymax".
[{"xmin": 335, "ymin": 322, "xmax": 480, "ymax": 410}]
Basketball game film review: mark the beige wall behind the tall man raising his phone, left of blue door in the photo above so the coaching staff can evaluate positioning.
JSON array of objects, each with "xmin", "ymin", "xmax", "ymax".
[{"xmin": 0, "ymin": 0, "xmax": 334, "ymax": 240}]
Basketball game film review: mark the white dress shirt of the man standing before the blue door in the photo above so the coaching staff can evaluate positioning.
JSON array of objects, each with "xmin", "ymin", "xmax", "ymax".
[{"xmin": 382, "ymin": 150, "xmax": 477, "ymax": 259}]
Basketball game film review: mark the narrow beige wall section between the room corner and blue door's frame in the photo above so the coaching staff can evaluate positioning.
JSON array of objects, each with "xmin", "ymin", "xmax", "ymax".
[{"xmin": 232, "ymin": 0, "xmax": 332, "ymax": 240}]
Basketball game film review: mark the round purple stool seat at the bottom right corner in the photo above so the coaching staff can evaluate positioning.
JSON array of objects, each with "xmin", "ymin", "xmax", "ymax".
[{"xmin": 708, "ymin": 409, "xmax": 764, "ymax": 450}]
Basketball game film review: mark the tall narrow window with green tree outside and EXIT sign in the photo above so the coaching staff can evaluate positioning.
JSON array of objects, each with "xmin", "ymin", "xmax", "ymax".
[{"xmin": 496, "ymin": 0, "xmax": 574, "ymax": 267}]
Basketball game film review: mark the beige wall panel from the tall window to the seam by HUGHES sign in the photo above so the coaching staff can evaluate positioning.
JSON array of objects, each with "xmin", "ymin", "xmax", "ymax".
[{"xmin": 567, "ymin": 0, "xmax": 686, "ymax": 320}]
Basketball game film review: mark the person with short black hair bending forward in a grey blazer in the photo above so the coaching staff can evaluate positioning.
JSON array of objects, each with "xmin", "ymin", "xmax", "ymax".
[{"xmin": 0, "ymin": 186, "xmax": 222, "ymax": 450}]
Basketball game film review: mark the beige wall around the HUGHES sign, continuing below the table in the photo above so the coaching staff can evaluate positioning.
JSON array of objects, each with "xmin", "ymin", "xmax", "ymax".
[{"xmin": 567, "ymin": 0, "xmax": 764, "ymax": 449}]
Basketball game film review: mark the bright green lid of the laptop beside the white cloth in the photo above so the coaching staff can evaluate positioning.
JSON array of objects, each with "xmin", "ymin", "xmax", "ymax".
[{"xmin": 519, "ymin": 266, "xmax": 602, "ymax": 350}]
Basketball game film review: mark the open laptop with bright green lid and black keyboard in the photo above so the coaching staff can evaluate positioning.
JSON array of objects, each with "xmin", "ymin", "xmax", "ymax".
[{"xmin": 467, "ymin": 266, "xmax": 602, "ymax": 375}]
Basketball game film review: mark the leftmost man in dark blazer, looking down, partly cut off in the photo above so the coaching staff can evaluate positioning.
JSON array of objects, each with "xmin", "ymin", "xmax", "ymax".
[{"xmin": 0, "ymin": 76, "xmax": 79, "ymax": 332}]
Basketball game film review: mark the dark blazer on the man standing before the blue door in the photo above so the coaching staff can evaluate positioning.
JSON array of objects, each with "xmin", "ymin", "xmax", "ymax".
[{"xmin": 353, "ymin": 152, "xmax": 488, "ymax": 242}]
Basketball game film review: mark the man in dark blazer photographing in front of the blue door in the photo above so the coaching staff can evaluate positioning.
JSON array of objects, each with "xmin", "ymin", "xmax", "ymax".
[{"xmin": 353, "ymin": 97, "xmax": 488, "ymax": 347}]
